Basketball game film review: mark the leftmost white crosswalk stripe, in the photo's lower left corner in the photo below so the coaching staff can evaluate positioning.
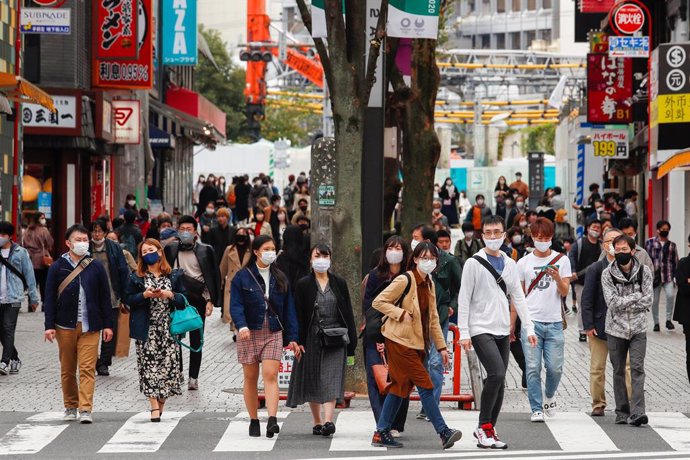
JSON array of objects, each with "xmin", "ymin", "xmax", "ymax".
[{"xmin": 0, "ymin": 412, "xmax": 69, "ymax": 455}]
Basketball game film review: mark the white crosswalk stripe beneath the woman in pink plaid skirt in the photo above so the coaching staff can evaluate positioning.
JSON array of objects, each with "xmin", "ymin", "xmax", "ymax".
[{"xmin": 213, "ymin": 411, "xmax": 290, "ymax": 452}]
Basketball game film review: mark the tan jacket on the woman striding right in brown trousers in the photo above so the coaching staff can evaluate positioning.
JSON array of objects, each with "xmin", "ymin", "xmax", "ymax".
[{"xmin": 371, "ymin": 271, "xmax": 446, "ymax": 350}]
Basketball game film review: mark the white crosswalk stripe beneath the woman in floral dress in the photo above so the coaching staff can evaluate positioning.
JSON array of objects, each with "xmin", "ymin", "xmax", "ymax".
[{"xmin": 98, "ymin": 412, "xmax": 189, "ymax": 454}]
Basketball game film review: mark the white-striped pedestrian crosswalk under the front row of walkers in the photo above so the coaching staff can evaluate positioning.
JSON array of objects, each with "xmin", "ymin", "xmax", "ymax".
[{"xmin": 0, "ymin": 410, "xmax": 690, "ymax": 458}]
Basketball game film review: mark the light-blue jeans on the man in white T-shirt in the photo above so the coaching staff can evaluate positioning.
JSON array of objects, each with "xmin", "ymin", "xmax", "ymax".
[{"xmin": 522, "ymin": 321, "xmax": 565, "ymax": 412}]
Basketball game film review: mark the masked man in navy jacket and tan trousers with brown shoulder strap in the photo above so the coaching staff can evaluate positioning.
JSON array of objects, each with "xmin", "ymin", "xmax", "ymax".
[{"xmin": 44, "ymin": 224, "xmax": 113, "ymax": 423}]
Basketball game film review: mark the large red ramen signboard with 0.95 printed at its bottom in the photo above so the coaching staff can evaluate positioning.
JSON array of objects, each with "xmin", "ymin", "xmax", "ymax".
[{"xmin": 93, "ymin": 0, "xmax": 153, "ymax": 89}]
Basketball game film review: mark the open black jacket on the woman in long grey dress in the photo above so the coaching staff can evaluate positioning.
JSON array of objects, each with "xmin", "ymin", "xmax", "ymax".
[{"xmin": 295, "ymin": 273, "xmax": 357, "ymax": 356}]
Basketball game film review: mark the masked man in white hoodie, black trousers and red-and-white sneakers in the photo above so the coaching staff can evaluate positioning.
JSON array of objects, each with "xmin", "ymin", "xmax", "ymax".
[{"xmin": 458, "ymin": 217, "xmax": 537, "ymax": 449}]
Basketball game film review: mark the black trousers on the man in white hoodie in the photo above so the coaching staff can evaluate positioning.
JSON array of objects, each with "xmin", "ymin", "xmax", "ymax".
[{"xmin": 472, "ymin": 334, "xmax": 510, "ymax": 425}]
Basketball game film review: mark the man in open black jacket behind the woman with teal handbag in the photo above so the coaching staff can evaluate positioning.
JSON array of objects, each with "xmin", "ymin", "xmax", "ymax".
[{"xmin": 165, "ymin": 216, "xmax": 222, "ymax": 391}]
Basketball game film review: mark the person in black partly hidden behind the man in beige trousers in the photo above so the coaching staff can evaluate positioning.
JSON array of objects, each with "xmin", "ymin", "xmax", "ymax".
[{"xmin": 568, "ymin": 219, "xmax": 602, "ymax": 342}]
